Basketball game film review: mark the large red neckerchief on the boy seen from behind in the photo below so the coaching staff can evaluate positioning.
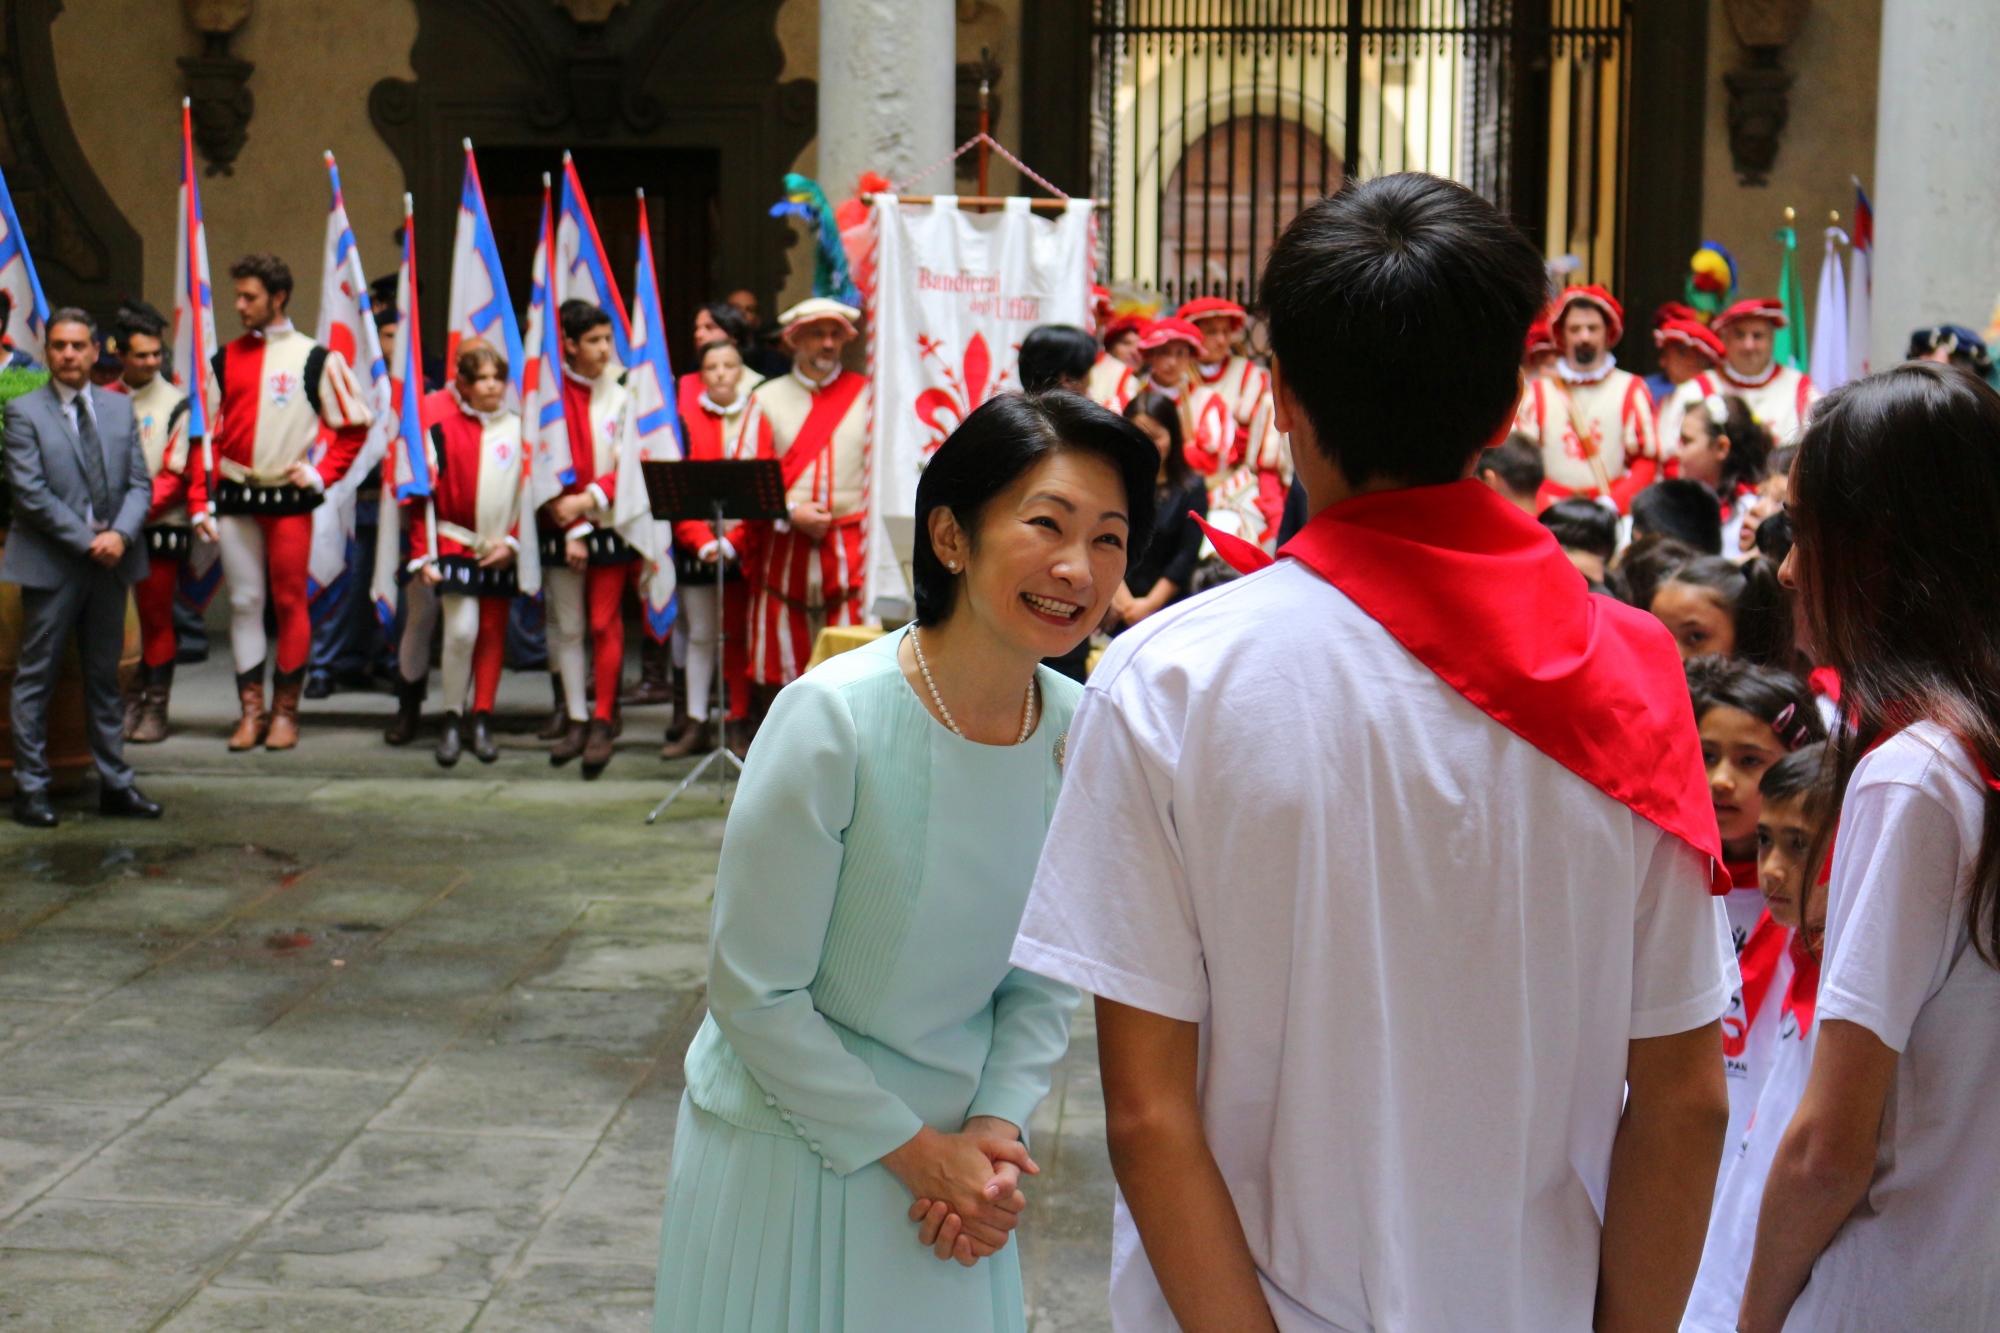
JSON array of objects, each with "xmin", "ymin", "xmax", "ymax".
[{"xmin": 1204, "ymin": 480, "xmax": 1730, "ymax": 895}]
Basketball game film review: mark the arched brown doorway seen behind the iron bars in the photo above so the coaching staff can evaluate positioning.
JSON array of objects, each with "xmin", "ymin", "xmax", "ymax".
[{"xmin": 1160, "ymin": 114, "xmax": 1342, "ymax": 302}]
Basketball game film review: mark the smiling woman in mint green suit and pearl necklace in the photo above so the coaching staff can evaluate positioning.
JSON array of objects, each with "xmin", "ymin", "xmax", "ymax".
[{"xmin": 654, "ymin": 394, "xmax": 1158, "ymax": 1333}]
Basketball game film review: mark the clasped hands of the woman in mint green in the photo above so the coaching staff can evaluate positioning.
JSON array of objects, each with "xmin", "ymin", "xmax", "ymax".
[{"xmin": 882, "ymin": 1115, "xmax": 1042, "ymax": 1267}]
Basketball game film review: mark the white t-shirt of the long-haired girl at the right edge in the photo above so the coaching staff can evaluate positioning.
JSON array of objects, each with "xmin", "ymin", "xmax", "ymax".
[{"xmin": 1784, "ymin": 723, "xmax": 2000, "ymax": 1333}]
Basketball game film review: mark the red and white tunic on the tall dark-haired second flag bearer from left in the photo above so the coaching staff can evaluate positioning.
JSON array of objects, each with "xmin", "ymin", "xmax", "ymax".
[{"xmin": 214, "ymin": 324, "xmax": 370, "ymax": 512}]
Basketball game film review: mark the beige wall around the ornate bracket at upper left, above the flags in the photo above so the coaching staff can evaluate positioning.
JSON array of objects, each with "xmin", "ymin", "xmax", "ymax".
[{"xmin": 54, "ymin": 0, "xmax": 418, "ymax": 338}]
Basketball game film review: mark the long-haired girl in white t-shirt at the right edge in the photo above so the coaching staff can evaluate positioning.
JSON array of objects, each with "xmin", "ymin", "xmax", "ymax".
[{"xmin": 1738, "ymin": 362, "xmax": 2000, "ymax": 1333}]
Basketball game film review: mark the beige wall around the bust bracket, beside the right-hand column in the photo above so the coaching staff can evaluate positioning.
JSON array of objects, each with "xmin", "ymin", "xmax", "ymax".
[{"xmin": 1696, "ymin": 0, "xmax": 1882, "ymax": 302}]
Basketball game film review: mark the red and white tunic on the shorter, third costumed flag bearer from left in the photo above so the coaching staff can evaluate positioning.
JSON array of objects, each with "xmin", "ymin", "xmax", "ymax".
[{"xmin": 406, "ymin": 392, "xmax": 522, "ymax": 592}]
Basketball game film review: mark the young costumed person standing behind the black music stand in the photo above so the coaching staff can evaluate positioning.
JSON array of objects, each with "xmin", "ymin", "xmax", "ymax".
[{"xmin": 660, "ymin": 336, "xmax": 770, "ymax": 759}]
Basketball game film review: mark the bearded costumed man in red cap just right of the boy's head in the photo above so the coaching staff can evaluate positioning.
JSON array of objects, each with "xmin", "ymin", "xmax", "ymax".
[{"xmin": 1518, "ymin": 286, "xmax": 1660, "ymax": 512}]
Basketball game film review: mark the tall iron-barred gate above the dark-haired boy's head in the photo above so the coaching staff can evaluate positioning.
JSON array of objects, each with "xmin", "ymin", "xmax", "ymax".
[{"xmin": 1092, "ymin": 0, "xmax": 1630, "ymax": 304}]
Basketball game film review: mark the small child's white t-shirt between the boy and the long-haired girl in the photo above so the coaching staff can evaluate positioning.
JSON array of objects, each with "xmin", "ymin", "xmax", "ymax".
[{"xmin": 1680, "ymin": 953, "xmax": 1820, "ymax": 1333}]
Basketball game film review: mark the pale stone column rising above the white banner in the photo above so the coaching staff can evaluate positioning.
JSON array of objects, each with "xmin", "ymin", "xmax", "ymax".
[{"xmin": 820, "ymin": 0, "xmax": 958, "ymax": 204}]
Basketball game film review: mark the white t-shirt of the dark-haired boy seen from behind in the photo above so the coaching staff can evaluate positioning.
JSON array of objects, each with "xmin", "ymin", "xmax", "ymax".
[{"xmin": 1014, "ymin": 560, "xmax": 1736, "ymax": 1333}]
